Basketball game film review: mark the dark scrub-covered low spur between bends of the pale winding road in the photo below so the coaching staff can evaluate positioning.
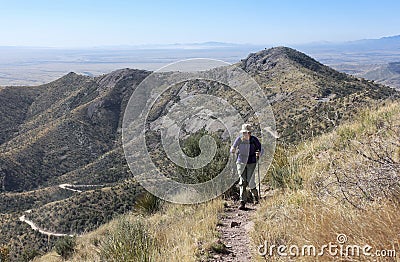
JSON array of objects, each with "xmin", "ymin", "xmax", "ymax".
[{"xmin": 26, "ymin": 181, "xmax": 144, "ymax": 235}]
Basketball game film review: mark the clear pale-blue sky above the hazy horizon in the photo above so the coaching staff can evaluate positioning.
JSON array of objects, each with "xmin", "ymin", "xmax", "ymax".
[{"xmin": 0, "ymin": 0, "xmax": 400, "ymax": 47}]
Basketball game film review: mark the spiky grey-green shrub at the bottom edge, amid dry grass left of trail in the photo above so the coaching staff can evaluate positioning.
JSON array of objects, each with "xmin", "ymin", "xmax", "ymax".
[{"xmin": 100, "ymin": 219, "xmax": 157, "ymax": 262}]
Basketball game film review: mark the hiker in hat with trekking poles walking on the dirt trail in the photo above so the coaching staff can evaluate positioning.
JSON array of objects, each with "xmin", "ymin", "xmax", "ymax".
[{"xmin": 230, "ymin": 124, "xmax": 264, "ymax": 210}]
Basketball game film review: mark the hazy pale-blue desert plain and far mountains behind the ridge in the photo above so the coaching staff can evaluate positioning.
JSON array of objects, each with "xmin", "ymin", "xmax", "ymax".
[{"xmin": 0, "ymin": 36, "xmax": 400, "ymax": 86}]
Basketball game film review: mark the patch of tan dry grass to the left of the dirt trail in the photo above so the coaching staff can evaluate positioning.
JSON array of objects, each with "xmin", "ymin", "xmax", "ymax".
[{"xmin": 35, "ymin": 199, "xmax": 223, "ymax": 262}]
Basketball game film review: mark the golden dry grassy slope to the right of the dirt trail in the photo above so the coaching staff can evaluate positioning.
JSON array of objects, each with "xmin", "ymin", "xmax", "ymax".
[{"xmin": 252, "ymin": 102, "xmax": 400, "ymax": 261}]
